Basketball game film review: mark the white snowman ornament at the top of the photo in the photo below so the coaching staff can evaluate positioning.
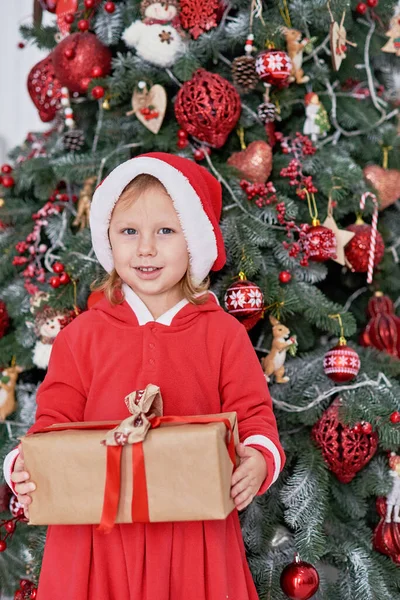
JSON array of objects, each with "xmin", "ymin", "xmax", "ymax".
[{"xmin": 122, "ymin": 0, "xmax": 185, "ymax": 67}]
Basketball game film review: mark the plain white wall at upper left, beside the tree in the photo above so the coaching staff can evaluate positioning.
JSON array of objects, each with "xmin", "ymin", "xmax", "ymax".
[{"xmin": 0, "ymin": 0, "xmax": 53, "ymax": 164}]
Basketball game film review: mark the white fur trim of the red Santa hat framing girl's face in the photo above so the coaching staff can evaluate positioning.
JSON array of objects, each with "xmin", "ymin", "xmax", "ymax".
[{"xmin": 90, "ymin": 156, "xmax": 218, "ymax": 284}]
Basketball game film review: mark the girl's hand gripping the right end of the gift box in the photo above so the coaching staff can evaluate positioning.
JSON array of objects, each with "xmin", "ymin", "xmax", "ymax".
[{"xmin": 231, "ymin": 444, "xmax": 267, "ymax": 510}]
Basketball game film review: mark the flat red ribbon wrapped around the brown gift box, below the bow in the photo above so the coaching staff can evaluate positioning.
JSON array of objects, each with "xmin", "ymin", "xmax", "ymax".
[{"xmin": 98, "ymin": 416, "xmax": 236, "ymax": 533}]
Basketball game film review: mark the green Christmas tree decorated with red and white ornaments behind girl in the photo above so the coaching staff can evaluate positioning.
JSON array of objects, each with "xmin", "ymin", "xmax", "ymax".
[{"xmin": 0, "ymin": 0, "xmax": 400, "ymax": 600}]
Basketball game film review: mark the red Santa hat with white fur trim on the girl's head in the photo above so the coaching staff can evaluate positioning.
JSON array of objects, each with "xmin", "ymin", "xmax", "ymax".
[{"xmin": 90, "ymin": 152, "xmax": 226, "ymax": 284}]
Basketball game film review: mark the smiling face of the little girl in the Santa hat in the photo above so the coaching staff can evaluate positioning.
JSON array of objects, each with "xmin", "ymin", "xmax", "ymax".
[{"xmin": 109, "ymin": 186, "xmax": 189, "ymax": 318}]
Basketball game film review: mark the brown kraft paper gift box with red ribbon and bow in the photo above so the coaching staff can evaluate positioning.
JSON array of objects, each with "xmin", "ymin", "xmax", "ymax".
[{"xmin": 21, "ymin": 384, "xmax": 238, "ymax": 532}]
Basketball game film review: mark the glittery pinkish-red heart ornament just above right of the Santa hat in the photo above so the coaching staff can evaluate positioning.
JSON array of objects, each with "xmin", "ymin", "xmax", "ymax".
[{"xmin": 227, "ymin": 140, "xmax": 272, "ymax": 183}]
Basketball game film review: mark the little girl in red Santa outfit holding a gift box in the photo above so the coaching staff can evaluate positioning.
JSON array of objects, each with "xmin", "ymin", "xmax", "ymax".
[{"xmin": 5, "ymin": 153, "xmax": 284, "ymax": 600}]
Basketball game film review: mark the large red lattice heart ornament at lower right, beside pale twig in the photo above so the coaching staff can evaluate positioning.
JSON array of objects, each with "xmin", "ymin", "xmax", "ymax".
[{"xmin": 312, "ymin": 399, "xmax": 378, "ymax": 483}]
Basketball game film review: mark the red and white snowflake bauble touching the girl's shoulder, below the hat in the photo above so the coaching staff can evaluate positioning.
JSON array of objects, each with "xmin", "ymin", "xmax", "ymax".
[{"xmin": 224, "ymin": 276, "xmax": 264, "ymax": 330}]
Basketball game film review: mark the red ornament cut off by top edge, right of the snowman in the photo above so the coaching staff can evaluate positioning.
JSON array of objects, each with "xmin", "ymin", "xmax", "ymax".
[{"xmin": 179, "ymin": 0, "xmax": 220, "ymax": 40}]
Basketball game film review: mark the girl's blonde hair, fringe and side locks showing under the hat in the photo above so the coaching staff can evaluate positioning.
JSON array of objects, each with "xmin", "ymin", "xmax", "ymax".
[{"xmin": 90, "ymin": 174, "xmax": 210, "ymax": 305}]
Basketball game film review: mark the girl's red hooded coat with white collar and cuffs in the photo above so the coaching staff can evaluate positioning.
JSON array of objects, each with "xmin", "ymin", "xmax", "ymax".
[{"xmin": 16, "ymin": 288, "xmax": 284, "ymax": 600}]
